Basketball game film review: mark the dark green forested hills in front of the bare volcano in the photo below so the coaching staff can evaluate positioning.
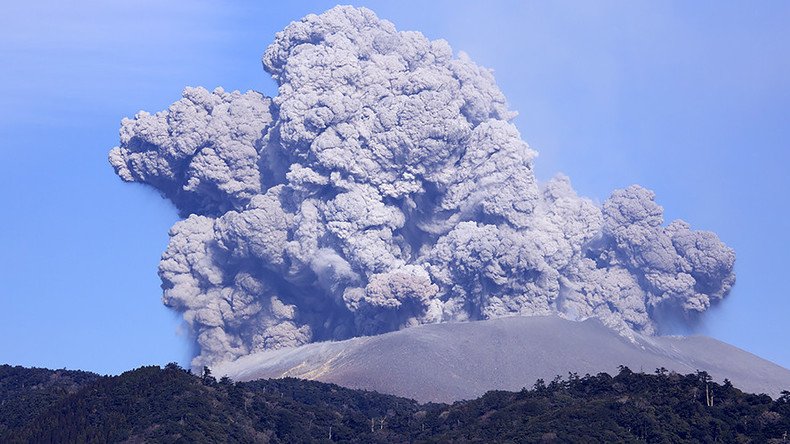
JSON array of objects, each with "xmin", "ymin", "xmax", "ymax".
[{"xmin": 0, "ymin": 364, "xmax": 790, "ymax": 443}]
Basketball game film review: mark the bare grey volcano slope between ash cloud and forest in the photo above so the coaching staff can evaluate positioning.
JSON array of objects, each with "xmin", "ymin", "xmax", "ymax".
[{"xmin": 214, "ymin": 316, "xmax": 790, "ymax": 402}]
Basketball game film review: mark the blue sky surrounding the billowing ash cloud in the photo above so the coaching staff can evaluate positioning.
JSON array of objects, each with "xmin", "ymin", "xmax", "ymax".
[{"xmin": 0, "ymin": 0, "xmax": 790, "ymax": 373}]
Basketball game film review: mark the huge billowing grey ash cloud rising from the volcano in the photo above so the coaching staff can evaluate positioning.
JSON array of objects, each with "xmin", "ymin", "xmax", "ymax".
[{"xmin": 110, "ymin": 7, "xmax": 735, "ymax": 365}]
